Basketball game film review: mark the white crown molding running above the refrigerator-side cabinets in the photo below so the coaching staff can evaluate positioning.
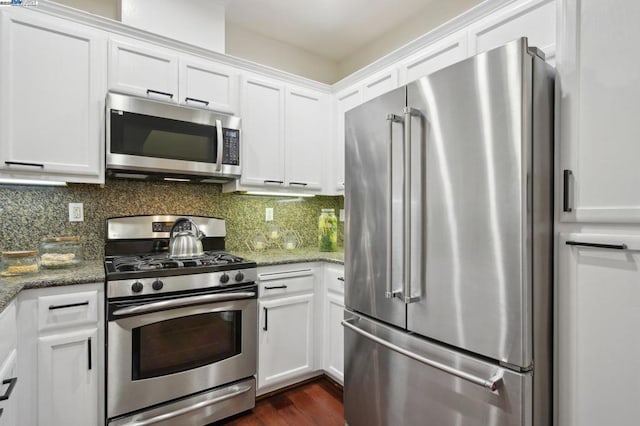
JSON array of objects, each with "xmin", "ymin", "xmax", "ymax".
[{"xmin": 331, "ymin": 0, "xmax": 520, "ymax": 93}]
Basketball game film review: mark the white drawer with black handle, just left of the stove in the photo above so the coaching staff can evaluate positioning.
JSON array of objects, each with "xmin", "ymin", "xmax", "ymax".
[{"xmin": 38, "ymin": 291, "xmax": 98, "ymax": 330}]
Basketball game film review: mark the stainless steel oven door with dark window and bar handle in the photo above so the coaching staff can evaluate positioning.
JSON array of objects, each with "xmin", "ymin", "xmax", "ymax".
[{"xmin": 107, "ymin": 290, "xmax": 257, "ymax": 418}]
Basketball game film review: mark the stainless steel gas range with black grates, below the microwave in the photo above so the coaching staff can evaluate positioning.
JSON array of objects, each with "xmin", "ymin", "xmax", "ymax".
[{"xmin": 105, "ymin": 215, "xmax": 257, "ymax": 426}]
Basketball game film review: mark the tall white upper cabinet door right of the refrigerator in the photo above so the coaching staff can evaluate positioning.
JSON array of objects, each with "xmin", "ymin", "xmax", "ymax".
[{"xmin": 556, "ymin": 0, "xmax": 640, "ymax": 223}]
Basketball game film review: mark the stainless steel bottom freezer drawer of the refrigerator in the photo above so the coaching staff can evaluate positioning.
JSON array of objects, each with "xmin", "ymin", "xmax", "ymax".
[{"xmin": 344, "ymin": 312, "xmax": 533, "ymax": 426}]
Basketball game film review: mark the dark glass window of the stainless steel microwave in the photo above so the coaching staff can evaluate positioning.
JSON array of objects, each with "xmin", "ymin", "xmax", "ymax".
[{"xmin": 111, "ymin": 111, "xmax": 217, "ymax": 163}]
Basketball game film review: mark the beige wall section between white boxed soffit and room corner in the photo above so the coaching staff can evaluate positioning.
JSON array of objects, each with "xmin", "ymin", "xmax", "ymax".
[{"xmin": 226, "ymin": 23, "xmax": 338, "ymax": 84}]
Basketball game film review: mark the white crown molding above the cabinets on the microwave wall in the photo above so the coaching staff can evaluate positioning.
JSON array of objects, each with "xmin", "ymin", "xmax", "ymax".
[{"xmin": 29, "ymin": 0, "xmax": 331, "ymax": 93}]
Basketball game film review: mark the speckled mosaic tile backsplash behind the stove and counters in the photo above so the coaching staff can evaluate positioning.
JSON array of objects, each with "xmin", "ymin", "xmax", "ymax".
[{"xmin": 0, "ymin": 179, "xmax": 344, "ymax": 259}]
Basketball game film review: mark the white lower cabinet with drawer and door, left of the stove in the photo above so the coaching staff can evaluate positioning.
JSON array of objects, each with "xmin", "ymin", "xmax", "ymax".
[{"xmin": 17, "ymin": 284, "xmax": 104, "ymax": 426}]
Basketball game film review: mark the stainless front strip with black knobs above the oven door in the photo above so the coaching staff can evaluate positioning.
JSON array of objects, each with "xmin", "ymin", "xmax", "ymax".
[{"xmin": 107, "ymin": 268, "xmax": 258, "ymax": 298}]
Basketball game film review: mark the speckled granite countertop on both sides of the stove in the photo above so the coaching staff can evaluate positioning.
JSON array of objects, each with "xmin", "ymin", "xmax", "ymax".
[{"xmin": 0, "ymin": 248, "xmax": 344, "ymax": 312}]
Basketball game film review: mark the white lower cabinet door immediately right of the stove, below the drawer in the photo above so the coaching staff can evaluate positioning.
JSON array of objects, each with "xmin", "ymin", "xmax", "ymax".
[{"xmin": 258, "ymin": 294, "xmax": 313, "ymax": 389}]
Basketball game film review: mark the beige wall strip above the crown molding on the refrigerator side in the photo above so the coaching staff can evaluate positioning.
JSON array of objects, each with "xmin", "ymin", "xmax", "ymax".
[{"xmin": 336, "ymin": 0, "xmax": 483, "ymax": 81}]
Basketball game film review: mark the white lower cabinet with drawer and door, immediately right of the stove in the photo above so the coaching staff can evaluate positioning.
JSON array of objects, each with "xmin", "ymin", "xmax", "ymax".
[{"xmin": 258, "ymin": 264, "xmax": 316, "ymax": 394}]
